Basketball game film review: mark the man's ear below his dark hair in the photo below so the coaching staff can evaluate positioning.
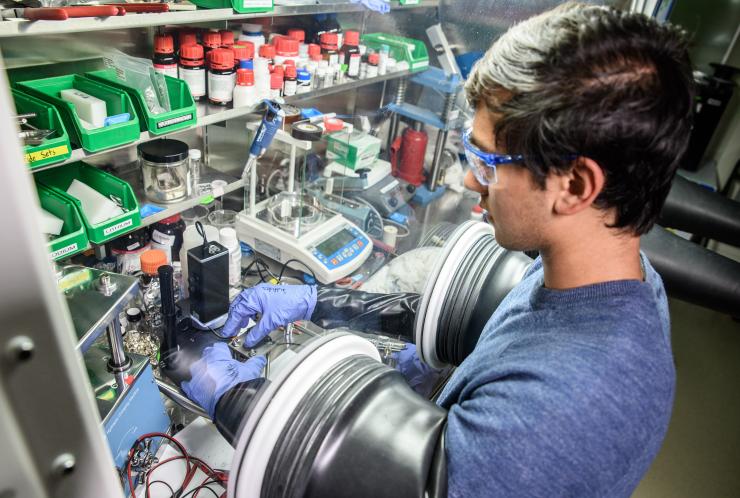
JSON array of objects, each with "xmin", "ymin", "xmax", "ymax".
[{"xmin": 553, "ymin": 157, "xmax": 606, "ymax": 214}]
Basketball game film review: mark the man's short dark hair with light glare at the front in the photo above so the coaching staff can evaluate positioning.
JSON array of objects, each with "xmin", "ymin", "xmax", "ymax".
[{"xmin": 466, "ymin": 3, "xmax": 693, "ymax": 235}]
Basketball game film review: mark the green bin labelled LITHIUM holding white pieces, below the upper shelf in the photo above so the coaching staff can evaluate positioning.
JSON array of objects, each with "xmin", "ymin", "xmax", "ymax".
[{"xmin": 36, "ymin": 162, "xmax": 141, "ymax": 244}]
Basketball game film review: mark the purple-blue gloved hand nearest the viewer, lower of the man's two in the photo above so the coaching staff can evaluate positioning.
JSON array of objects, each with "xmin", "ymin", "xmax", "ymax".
[{"xmin": 181, "ymin": 342, "xmax": 267, "ymax": 418}]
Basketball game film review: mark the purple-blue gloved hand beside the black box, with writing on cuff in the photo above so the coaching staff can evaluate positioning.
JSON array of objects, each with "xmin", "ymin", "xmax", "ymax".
[{"xmin": 221, "ymin": 284, "xmax": 316, "ymax": 348}]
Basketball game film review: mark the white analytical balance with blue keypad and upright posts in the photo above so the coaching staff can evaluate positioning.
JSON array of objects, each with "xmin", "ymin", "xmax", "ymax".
[{"xmin": 236, "ymin": 120, "xmax": 372, "ymax": 284}]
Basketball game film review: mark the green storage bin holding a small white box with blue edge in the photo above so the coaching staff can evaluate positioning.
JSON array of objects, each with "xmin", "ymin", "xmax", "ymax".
[{"xmin": 18, "ymin": 74, "xmax": 141, "ymax": 152}]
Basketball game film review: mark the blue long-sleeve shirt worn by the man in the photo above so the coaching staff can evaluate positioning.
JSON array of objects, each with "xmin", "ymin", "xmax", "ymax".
[{"xmin": 438, "ymin": 256, "xmax": 675, "ymax": 498}]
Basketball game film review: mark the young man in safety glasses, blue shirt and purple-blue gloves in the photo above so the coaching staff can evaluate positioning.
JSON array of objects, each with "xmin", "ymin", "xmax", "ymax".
[{"xmin": 179, "ymin": 3, "xmax": 692, "ymax": 498}]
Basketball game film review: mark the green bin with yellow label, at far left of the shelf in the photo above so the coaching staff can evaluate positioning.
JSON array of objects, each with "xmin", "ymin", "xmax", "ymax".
[{"xmin": 11, "ymin": 89, "xmax": 72, "ymax": 169}]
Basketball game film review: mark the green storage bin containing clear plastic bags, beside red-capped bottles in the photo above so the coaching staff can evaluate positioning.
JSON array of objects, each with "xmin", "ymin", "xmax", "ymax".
[{"xmin": 86, "ymin": 69, "xmax": 197, "ymax": 135}]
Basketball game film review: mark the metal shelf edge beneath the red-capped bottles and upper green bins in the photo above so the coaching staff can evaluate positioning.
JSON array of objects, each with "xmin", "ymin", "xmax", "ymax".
[{"xmin": 33, "ymin": 68, "xmax": 413, "ymax": 173}]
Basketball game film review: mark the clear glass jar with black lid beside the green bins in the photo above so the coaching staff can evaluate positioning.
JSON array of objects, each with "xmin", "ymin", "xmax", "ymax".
[{"xmin": 137, "ymin": 138, "xmax": 190, "ymax": 204}]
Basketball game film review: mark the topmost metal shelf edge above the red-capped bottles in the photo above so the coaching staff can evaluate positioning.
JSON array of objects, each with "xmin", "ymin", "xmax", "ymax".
[{"xmin": 0, "ymin": 0, "xmax": 439, "ymax": 38}]
